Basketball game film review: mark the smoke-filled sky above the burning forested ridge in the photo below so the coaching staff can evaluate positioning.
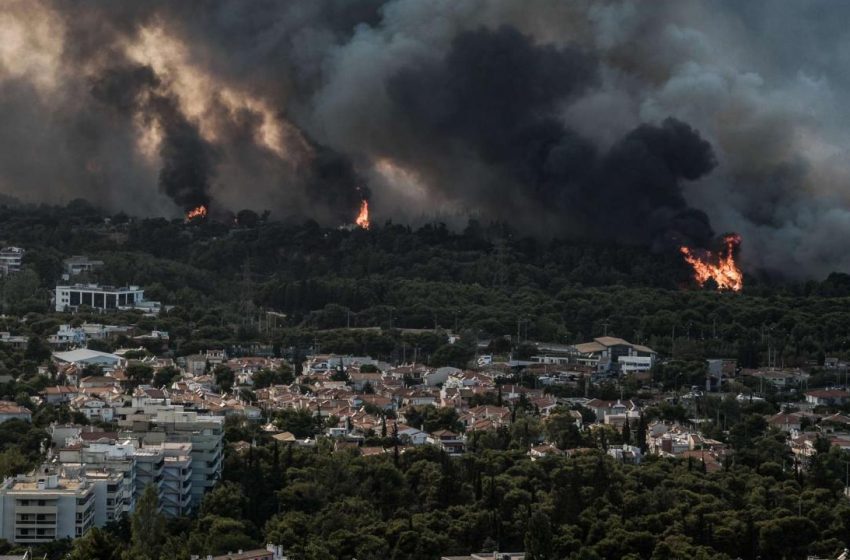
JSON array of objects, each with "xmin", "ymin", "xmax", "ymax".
[{"xmin": 0, "ymin": 0, "xmax": 850, "ymax": 277}]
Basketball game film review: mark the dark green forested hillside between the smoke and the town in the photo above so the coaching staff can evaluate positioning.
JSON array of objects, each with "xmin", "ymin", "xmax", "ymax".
[{"xmin": 0, "ymin": 201, "xmax": 850, "ymax": 366}]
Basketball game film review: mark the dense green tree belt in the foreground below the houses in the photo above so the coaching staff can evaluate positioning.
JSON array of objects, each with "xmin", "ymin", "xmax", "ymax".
[{"xmin": 48, "ymin": 417, "xmax": 850, "ymax": 560}]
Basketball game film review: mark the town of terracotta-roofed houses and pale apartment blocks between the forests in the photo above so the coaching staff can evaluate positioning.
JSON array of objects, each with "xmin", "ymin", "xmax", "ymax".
[{"xmin": 0, "ymin": 247, "xmax": 850, "ymax": 560}]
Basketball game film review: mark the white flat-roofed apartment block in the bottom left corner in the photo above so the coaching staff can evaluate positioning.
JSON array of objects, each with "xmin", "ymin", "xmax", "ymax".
[{"xmin": 0, "ymin": 470, "xmax": 95, "ymax": 544}]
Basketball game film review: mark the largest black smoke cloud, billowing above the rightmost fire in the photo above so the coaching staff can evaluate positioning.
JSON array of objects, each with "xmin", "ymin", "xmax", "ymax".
[{"xmin": 388, "ymin": 26, "xmax": 715, "ymax": 246}]
